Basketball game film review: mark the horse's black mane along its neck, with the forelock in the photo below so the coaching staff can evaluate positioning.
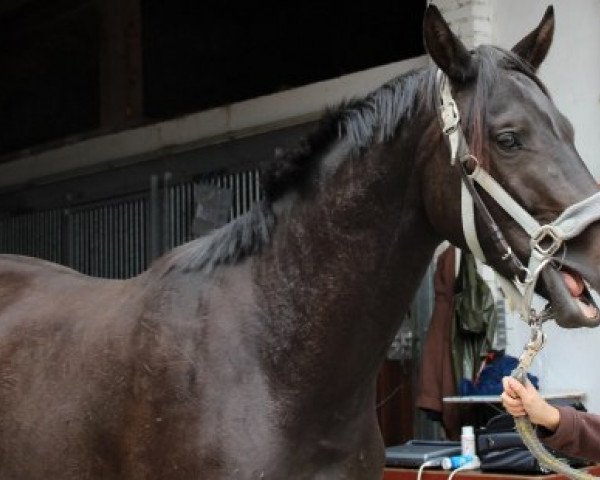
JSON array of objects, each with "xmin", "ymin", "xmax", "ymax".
[{"xmin": 165, "ymin": 46, "xmax": 547, "ymax": 278}]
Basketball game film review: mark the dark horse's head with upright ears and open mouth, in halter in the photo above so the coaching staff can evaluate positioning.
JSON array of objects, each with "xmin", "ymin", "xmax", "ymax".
[{"xmin": 424, "ymin": 6, "xmax": 600, "ymax": 327}]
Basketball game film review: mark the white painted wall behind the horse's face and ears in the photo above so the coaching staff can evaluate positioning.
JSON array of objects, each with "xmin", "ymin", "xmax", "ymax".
[{"xmin": 489, "ymin": 0, "xmax": 600, "ymax": 413}]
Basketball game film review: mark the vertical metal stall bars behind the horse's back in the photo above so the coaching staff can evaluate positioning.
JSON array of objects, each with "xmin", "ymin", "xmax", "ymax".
[{"xmin": 0, "ymin": 170, "xmax": 262, "ymax": 278}]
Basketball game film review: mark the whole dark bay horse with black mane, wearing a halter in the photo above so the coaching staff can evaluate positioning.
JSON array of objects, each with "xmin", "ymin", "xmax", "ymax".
[{"xmin": 0, "ymin": 6, "xmax": 600, "ymax": 480}]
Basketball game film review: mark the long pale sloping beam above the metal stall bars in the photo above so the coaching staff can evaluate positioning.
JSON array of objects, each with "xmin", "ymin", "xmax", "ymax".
[{"xmin": 0, "ymin": 55, "xmax": 429, "ymax": 191}]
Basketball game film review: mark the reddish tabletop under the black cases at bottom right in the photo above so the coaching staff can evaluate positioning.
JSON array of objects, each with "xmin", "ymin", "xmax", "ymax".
[{"xmin": 383, "ymin": 465, "xmax": 600, "ymax": 480}]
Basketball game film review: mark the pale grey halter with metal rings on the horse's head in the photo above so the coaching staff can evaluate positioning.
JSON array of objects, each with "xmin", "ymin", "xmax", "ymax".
[{"xmin": 436, "ymin": 70, "xmax": 600, "ymax": 323}]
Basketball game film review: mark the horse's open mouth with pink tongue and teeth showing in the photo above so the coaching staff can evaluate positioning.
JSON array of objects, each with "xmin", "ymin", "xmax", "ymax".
[{"xmin": 542, "ymin": 267, "xmax": 600, "ymax": 328}]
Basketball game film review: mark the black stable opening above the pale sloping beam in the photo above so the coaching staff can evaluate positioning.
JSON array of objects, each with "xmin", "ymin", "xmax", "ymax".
[{"xmin": 0, "ymin": 0, "xmax": 425, "ymax": 161}]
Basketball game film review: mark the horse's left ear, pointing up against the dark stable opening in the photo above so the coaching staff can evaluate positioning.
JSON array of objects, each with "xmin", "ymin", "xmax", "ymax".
[{"xmin": 423, "ymin": 5, "xmax": 475, "ymax": 82}]
